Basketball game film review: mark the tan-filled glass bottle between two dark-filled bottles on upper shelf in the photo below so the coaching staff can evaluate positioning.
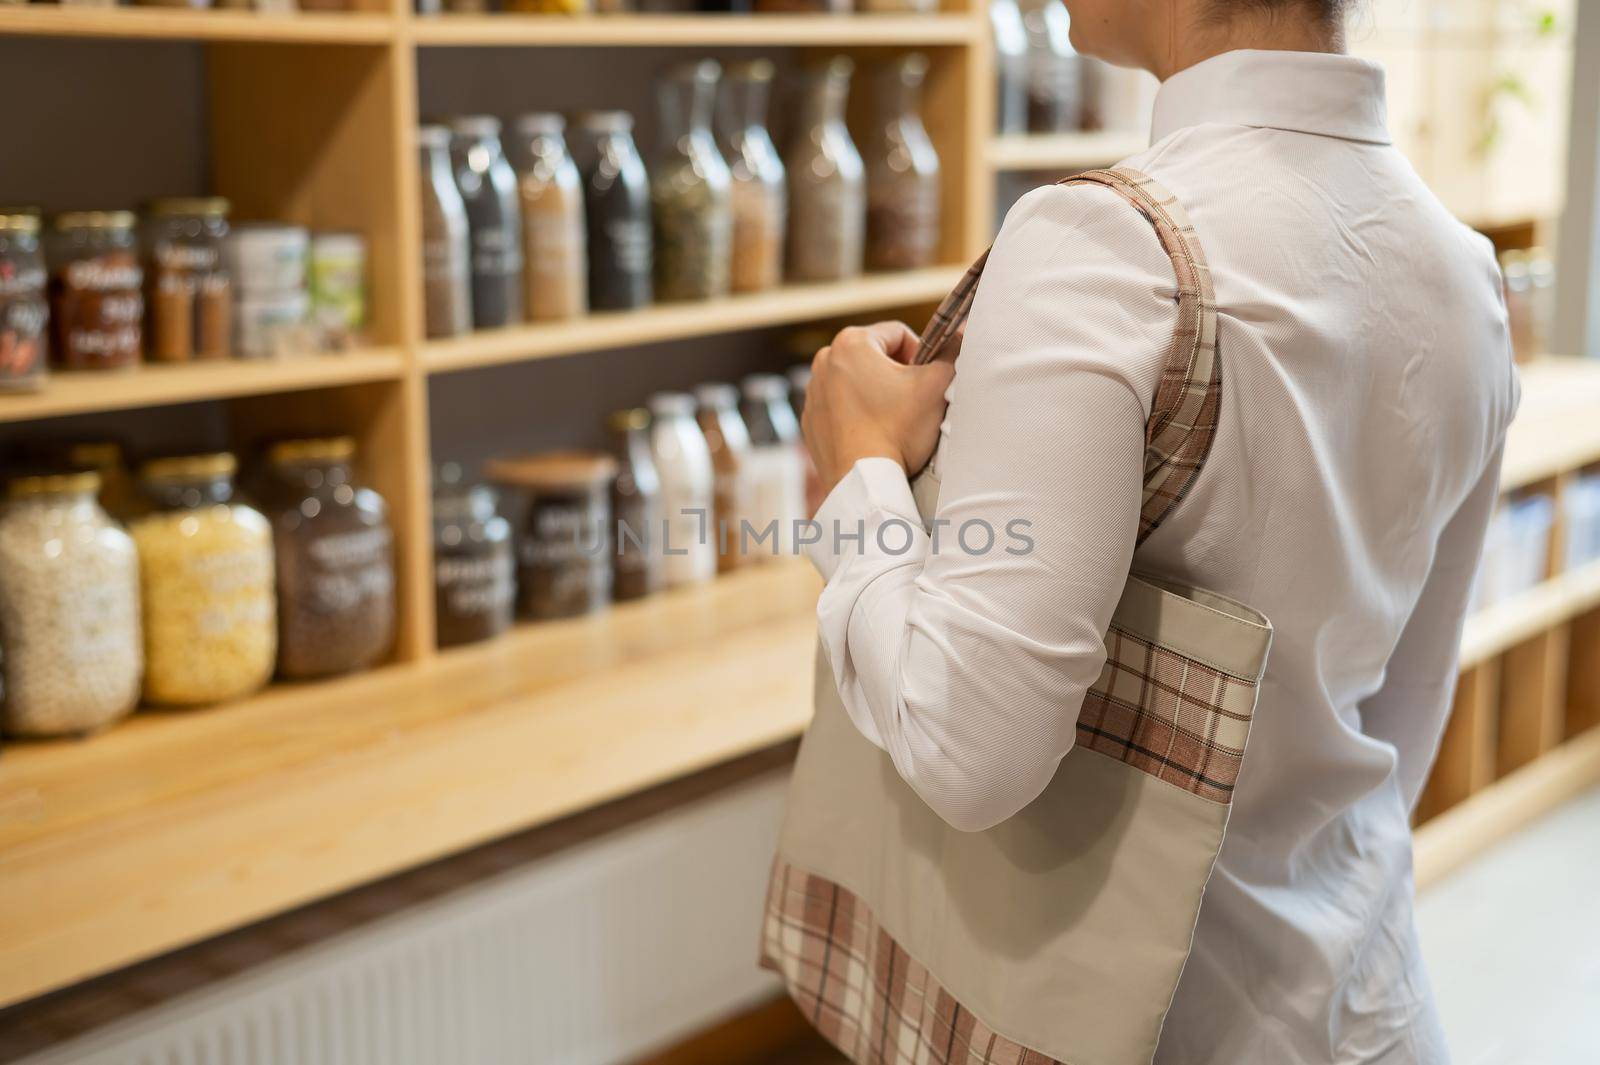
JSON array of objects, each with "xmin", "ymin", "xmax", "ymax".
[{"xmin": 514, "ymin": 114, "xmax": 589, "ymax": 321}]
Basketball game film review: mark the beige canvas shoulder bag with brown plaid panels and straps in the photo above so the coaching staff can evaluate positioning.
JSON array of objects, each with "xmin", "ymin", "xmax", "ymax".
[{"xmin": 762, "ymin": 170, "xmax": 1272, "ymax": 1065}]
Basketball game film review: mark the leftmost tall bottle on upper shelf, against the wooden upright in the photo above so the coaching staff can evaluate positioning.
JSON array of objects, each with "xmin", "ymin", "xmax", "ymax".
[{"xmin": 416, "ymin": 126, "xmax": 472, "ymax": 339}]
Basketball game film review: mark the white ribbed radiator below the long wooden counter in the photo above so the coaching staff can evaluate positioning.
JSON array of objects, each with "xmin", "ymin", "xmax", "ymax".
[{"xmin": 10, "ymin": 772, "xmax": 786, "ymax": 1065}]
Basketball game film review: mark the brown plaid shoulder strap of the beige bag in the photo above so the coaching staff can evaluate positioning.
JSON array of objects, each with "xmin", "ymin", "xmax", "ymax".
[{"xmin": 917, "ymin": 168, "xmax": 1222, "ymax": 544}]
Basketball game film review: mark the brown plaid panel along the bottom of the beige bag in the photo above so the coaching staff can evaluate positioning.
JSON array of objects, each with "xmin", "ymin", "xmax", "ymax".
[{"xmin": 762, "ymin": 857, "xmax": 1062, "ymax": 1065}]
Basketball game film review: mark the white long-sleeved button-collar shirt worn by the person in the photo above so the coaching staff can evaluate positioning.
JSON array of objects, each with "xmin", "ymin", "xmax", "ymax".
[{"xmin": 813, "ymin": 51, "xmax": 1518, "ymax": 1065}]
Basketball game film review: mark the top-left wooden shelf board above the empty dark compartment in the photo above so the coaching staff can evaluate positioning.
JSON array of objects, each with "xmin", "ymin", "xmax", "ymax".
[{"xmin": 0, "ymin": 3, "xmax": 395, "ymax": 45}]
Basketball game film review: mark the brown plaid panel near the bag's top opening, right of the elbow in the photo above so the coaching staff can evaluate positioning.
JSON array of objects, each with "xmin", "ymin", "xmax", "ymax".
[{"xmin": 1077, "ymin": 628, "xmax": 1256, "ymax": 803}]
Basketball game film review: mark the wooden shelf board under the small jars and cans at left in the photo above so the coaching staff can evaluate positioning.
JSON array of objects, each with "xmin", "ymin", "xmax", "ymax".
[{"xmin": 0, "ymin": 349, "xmax": 403, "ymax": 422}]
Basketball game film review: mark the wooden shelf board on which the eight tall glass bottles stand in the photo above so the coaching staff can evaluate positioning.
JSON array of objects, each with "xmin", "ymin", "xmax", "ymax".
[{"xmin": 422, "ymin": 267, "xmax": 965, "ymax": 373}]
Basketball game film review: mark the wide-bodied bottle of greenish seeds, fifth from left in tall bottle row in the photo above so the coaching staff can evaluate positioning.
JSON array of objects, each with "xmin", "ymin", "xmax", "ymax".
[{"xmin": 650, "ymin": 59, "xmax": 733, "ymax": 301}]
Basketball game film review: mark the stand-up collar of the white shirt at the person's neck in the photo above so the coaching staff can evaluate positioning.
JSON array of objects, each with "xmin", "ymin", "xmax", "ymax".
[{"xmin": 1150, "ymin": 50, "xmax": 1390, "ymax": 144}]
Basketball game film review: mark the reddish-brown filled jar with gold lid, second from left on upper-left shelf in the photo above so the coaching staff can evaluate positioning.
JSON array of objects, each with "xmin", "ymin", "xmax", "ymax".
[{"xmin": 45, "ymin": 211, "xmax": 144, "ymax": 369}]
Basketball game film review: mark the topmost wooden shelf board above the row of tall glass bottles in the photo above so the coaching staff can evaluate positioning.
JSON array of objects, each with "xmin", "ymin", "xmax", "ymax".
[{"xmin": 410, "ymin": 14, "xmax": 978, "ymax": 48}]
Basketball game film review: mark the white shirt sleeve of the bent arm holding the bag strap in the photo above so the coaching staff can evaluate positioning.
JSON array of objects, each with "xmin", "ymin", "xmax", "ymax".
[{"xmin": 810, "ymin": 185, "xmax": 1176, "ymax": 830}]
